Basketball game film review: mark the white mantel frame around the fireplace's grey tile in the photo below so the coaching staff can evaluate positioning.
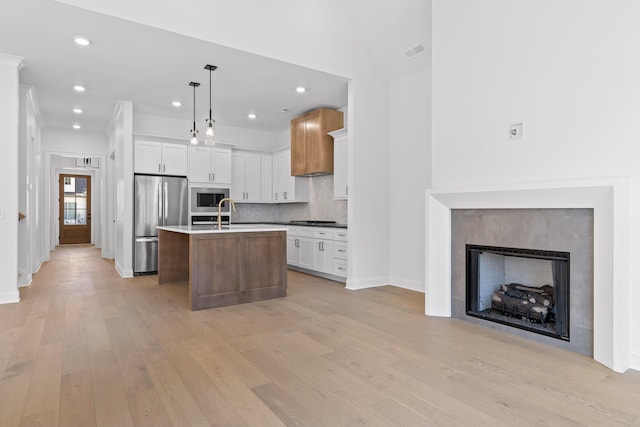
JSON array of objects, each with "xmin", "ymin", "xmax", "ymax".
[{"xmin": 425, "ymin": 178, "xmax": 631, "ymax": 372}]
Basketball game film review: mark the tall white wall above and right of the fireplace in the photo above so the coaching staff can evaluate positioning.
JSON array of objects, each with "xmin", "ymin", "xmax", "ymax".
[{"xmin": 432, "ymin": 0, "xmax": 640, "ymax": 369}]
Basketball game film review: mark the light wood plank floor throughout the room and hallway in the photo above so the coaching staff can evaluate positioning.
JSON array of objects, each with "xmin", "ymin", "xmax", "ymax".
[{"xmin": 0, "ymin": 246, "xmax": 640, "ymax": 427}]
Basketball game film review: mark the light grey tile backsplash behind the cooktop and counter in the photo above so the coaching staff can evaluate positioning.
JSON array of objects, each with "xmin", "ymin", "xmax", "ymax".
[{"xmin": 232, "ymin": 175, "xmax": 347, "ymax": 224}]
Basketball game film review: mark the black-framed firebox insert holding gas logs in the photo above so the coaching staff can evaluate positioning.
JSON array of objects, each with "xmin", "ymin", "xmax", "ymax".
[{"xmin": 465, "ymin": 244, "xmax": 570, "ymax": 341}]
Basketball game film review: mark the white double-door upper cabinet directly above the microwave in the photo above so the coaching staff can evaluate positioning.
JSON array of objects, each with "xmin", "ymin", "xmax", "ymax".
[{"xmin": 189, "ymin": 146, "xmax": 231, "ymax": 184}]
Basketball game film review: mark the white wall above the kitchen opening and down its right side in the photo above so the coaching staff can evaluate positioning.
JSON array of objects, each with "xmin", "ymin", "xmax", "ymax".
[{"xmin": 57, "ymin": 0, "xmax": 389, "ymax": 288}]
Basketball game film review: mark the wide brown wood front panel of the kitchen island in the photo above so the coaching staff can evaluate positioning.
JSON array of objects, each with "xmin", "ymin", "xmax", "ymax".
[{"xmin": 189, "ymin": 231, "xmax": 287, "ymax": 310}]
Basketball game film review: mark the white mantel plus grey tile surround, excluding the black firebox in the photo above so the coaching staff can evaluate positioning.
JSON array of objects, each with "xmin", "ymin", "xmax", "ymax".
[{"xmin": 425, "ymin": 182, "xmax": 640, "ymax": 372}]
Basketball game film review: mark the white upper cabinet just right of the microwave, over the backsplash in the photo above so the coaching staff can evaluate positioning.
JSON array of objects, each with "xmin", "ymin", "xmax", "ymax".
[{"xmin": 230, "ymin": 152, "xmax": 262, "ymax": 203}]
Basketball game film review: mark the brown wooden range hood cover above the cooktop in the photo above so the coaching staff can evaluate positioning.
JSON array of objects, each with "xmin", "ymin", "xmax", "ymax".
[{"xmin": 291, "ymin": 108, "xmax": 344, "ymax": 176}]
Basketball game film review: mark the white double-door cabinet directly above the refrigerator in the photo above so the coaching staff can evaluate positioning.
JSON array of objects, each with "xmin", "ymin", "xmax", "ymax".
[{"xmin": 134, "ymin": 141, "xmax": 188, "ymax": 176}]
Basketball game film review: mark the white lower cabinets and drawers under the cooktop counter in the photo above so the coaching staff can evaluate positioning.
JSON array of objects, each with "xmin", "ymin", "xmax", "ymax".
[{"xmin": 287, "ymin": 227, "xmax": 348, "ymax": 278}]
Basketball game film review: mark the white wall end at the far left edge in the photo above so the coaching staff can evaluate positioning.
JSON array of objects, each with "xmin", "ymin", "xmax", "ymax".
[{"xmin": 0, "ymin": 53, "xmax": 22, "ymax": 303}]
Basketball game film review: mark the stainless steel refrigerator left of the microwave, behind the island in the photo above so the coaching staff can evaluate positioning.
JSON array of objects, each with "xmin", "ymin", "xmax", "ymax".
[{"xmin": 133, "ymin": 175, "xmax": 189, "ymax": 274}]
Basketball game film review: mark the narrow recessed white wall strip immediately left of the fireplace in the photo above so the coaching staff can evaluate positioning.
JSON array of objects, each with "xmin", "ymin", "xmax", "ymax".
[{"xmin": 389, "ymin": 69, "xmax": 431, "ymax": 292}]
